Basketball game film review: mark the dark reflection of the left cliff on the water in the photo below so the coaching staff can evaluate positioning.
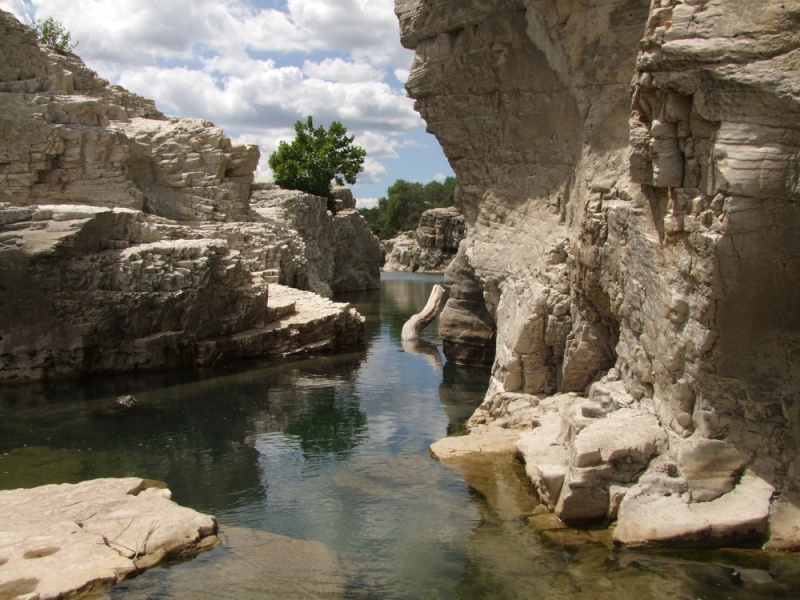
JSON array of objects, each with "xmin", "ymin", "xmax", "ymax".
[{"xmin": 0, "ymin": 354, "xmax": 367, "ymax": 512}]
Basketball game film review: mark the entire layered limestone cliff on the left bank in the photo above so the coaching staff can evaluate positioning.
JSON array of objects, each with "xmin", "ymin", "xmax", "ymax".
[{"xmin": 0, "ymin": 11, "xmax": 380, "ymax": 379}]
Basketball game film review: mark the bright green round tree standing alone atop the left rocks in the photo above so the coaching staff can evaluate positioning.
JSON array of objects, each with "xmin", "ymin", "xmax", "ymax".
[{"xmin": 269, "ymin": 117, "xmax": 367, "ymax": 211}]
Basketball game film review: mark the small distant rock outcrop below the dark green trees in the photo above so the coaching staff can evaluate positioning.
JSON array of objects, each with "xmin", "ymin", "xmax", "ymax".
[{"xmin": 383, "ymin": 207, "xmax": 466, "ymax": 273}]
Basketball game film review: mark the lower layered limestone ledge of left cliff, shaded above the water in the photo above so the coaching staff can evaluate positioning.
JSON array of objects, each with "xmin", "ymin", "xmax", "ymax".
[{"xmin": 0, "ymin": 199, "xmax": 366, "ymax": 380}]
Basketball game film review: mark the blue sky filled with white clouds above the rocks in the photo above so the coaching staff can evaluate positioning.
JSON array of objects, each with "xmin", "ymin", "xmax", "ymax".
[{"xmin": 0, "ymin": 0, "xmax": 453, "ymax": 208}]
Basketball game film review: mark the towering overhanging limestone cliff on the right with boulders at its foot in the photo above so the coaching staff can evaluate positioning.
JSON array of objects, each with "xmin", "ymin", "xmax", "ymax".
[{"xmin": 396, "ymin": 0, "xmax": 800, "ymax": 548}]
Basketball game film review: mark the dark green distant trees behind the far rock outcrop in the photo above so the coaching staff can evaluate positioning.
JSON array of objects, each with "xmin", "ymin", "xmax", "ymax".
[{"xmin": 358, "ymin": 177, "xmax": 456, "ymax": 240}]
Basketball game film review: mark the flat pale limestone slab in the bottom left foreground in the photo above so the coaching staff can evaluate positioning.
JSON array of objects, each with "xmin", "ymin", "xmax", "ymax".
[{"xmin": 0, "ymin": 477, "xmax": 217, "ymax": 600}]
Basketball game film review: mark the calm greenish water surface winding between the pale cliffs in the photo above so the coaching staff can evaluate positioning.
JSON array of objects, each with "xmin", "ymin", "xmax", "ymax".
[{"xmin": 0, "ymin": 274, "xmax": 800, "ymax": 600}]
